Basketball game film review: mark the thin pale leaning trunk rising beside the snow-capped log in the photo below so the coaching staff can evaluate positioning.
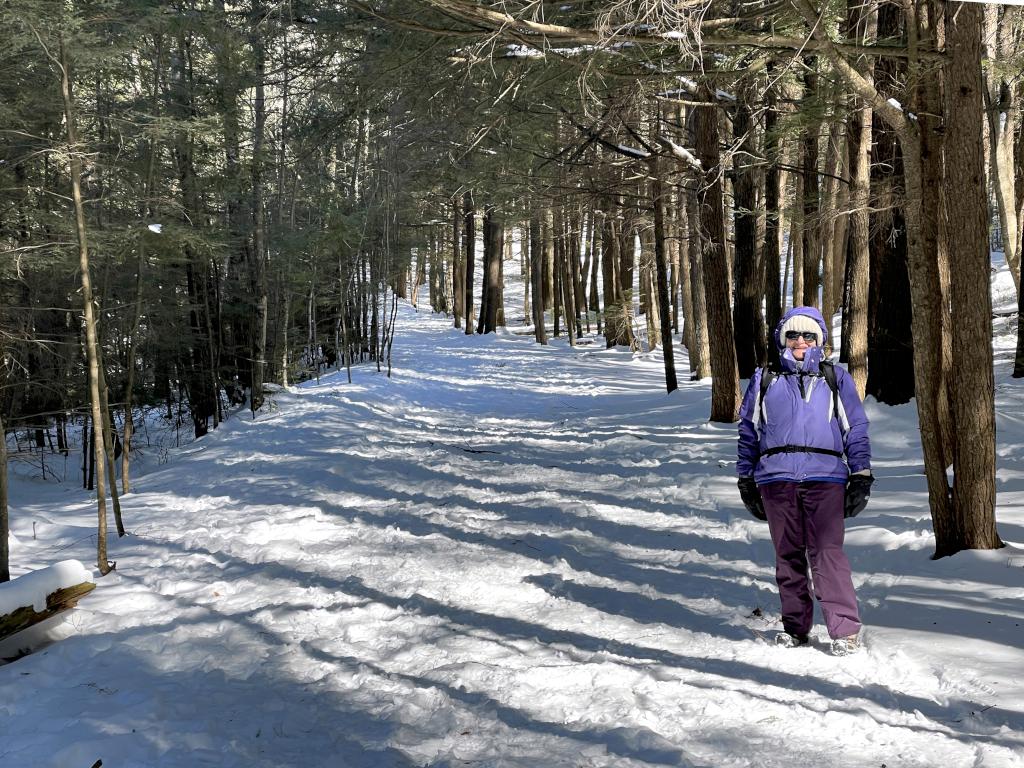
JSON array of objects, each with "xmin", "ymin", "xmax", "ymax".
[{"xmin": 59, "ymin": 37, "xmax": 111, "ymax": 575}]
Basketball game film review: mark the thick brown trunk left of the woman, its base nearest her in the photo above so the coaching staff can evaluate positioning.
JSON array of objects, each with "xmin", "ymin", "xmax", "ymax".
[{"xmin": 693, "ymin": 93, "xmax": 739, "ymax": 423}]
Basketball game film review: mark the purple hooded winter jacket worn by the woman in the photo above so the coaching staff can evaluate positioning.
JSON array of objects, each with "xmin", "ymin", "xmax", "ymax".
[{"xmin": 736, "ymin": 307, "xmax": 871, "ymax": 485}]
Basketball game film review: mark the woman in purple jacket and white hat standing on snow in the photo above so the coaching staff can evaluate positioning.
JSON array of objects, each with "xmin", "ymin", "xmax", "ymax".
[{"xmin": 736, "ymin": 306, "xmax": 873, "ymax": 655}]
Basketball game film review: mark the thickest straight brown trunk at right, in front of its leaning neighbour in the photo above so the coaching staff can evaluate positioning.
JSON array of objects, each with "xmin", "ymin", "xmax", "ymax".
[{"xmin": 934, "ymin": 2, "xmax": 1002, "ymax": 557}]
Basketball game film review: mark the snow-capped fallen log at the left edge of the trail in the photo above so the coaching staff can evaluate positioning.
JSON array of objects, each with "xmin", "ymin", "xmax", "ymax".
[{"xmin": 0, "ymin": 560, "xmax": 96, "ymax": 640}]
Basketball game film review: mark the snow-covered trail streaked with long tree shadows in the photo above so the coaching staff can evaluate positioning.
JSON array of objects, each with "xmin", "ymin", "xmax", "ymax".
[{"xmin": 6, "ymin": 307, "xmax": 1024, "ymax": 768}]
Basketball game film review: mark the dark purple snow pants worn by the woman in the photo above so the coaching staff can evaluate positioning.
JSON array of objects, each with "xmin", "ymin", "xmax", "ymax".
[{"xmin": 760, "ymin": 482, "xmax": 860, "ymax": 639}]
